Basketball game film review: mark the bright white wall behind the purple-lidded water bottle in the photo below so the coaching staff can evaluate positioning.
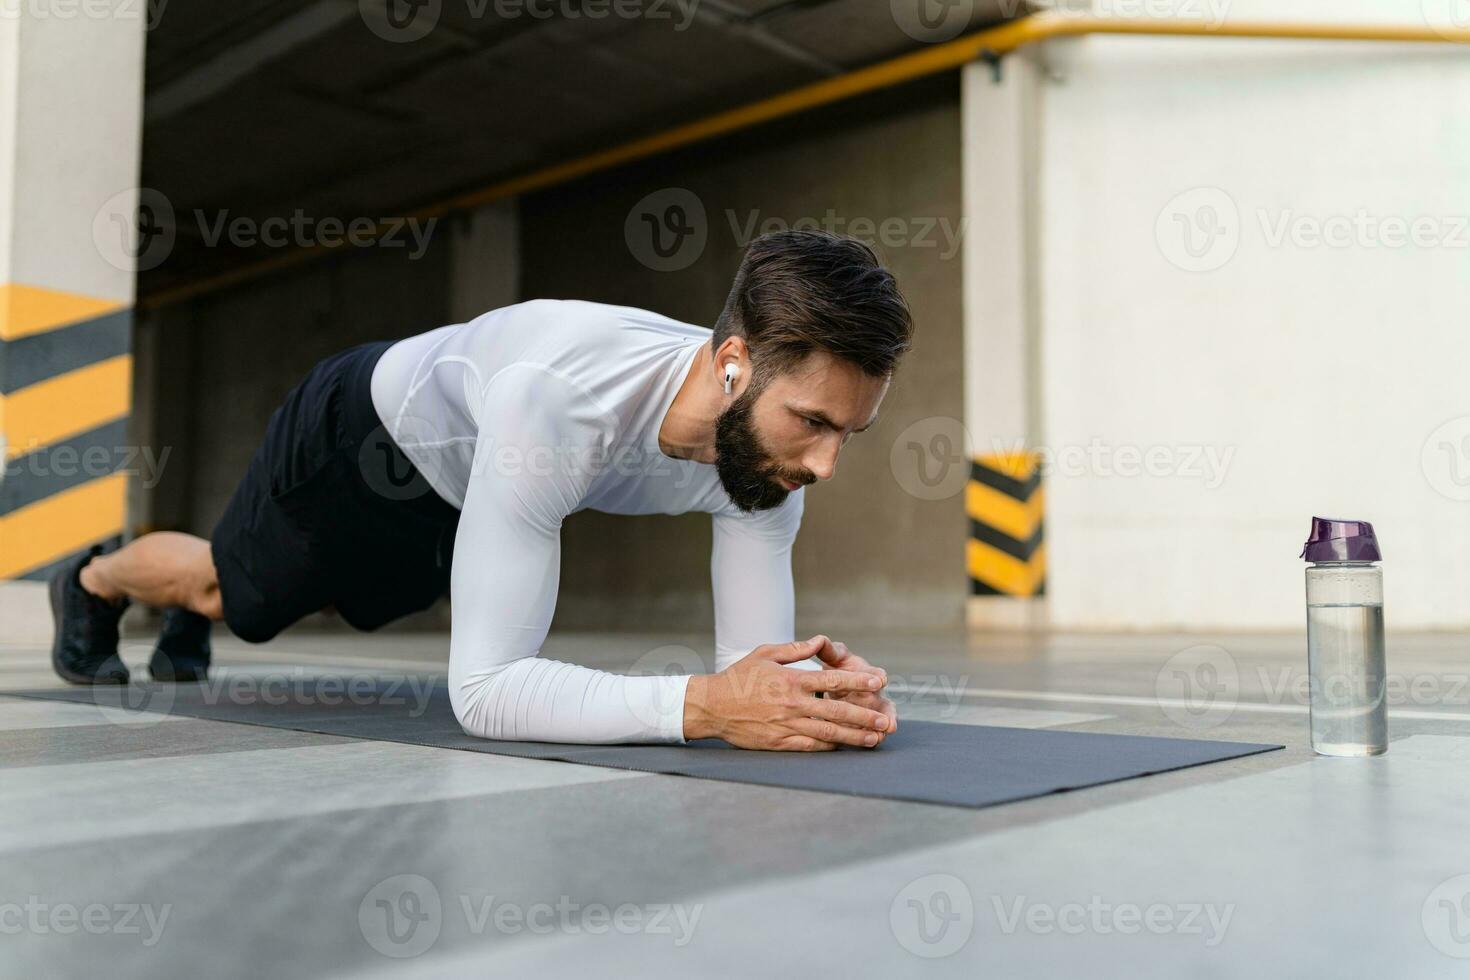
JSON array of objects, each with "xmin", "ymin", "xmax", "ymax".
[{"xmin": 1038, "ymin": 3, "xmax": 1470, "ymax": 629}]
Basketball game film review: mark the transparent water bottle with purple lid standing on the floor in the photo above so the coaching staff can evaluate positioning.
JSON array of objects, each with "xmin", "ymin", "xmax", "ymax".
[{"xmin": 1301, "ymin": 517, "xmax": 1388, "ymax": 755}]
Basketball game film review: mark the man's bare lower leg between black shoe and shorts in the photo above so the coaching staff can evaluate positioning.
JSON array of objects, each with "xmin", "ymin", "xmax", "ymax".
[{"xmin": 78, "ymin": 530, "xmax": 223, "ymax": 620}]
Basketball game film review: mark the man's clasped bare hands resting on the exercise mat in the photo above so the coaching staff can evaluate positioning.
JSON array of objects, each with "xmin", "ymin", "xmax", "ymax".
[{"xmin": 684, "ymin": 636, "xmax": 892, "ymax": 752}]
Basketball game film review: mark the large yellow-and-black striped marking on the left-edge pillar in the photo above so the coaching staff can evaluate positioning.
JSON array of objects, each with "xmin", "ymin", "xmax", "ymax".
[{"xmin": 0, "ymin": 284, "xmax": 132, "ymax": 579}]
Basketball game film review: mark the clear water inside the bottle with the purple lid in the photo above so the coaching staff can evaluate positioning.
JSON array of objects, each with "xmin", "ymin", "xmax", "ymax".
[{"xmin": 1307, "ymin": 604, "xmax": 1388, "ymax": 755}]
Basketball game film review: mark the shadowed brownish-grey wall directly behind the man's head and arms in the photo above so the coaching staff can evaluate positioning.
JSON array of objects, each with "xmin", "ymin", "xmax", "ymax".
[{"xmin": 522, "ymin": 76, "xmax": 966, "ymax": 630}]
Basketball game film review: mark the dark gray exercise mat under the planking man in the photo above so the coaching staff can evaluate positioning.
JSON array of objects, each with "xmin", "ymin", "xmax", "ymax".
[{"xmin": 3, "ymin": 676, "xmax": 1282, "ymax": 807}]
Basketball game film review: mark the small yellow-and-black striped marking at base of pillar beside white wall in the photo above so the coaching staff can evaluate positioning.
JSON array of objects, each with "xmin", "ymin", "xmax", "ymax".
[{"xmin": 964, "ymin": 453, "xmax": 1047, "ymax": 597}]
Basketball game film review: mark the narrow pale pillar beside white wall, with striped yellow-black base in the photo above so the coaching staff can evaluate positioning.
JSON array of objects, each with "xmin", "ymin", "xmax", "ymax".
[{"xmin": 961, "ymin": 54, "xmax": 1047, "ymax": 629}]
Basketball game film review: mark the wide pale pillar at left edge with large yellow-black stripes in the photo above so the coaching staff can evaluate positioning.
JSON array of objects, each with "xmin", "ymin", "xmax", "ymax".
[{"xmin": 0, "ymin": 7, "xmax": 146, "ymax": 593}]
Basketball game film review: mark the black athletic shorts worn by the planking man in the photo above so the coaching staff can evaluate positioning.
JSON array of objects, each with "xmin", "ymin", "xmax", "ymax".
[{"xmin": 210, "ymin": 342, "xmax": 459, "ymax": 644}]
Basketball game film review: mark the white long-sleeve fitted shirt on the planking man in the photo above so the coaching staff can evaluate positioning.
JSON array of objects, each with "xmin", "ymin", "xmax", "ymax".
[{"xmin": 372, "ymin": 300, "xmax": 804, "ymax": 742}]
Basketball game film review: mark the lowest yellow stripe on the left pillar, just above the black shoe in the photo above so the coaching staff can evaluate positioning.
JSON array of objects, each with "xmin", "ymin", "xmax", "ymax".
[{"xmin": 0, "ymin": 473, "xmax": 128, "ymax": 579}]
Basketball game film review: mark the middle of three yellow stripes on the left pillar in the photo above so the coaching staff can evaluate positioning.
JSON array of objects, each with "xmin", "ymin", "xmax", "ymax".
[{"xmin": 0, "ymin": 354, "xmax": 132, "ymax": 460}]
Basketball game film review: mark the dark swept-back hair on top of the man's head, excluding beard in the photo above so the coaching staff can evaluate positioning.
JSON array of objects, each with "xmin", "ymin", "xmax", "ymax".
[{"xmin": 714, "ymin": 231, "xmax": 913, "ymax": 381}]
